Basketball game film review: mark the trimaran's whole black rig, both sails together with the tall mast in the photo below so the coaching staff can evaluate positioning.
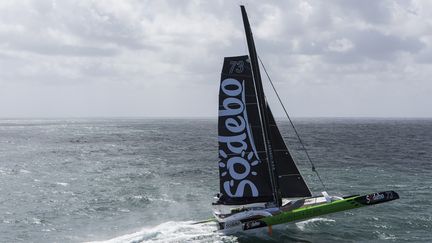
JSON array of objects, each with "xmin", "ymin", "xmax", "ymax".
[{"xmin": 218, "ymin": 6, "xmax": 311, "ymax": 205}]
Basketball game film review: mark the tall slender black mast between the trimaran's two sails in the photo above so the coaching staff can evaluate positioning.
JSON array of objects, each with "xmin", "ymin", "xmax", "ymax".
[{"xmin": 240, "ymin": 5, "xmax": 281, "ymax": 206}]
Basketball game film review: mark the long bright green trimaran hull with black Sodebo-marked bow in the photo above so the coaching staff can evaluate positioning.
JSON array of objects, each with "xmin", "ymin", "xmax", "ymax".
[{"xmin": 226, "ymin": 191, "xmax": 399, "ymax": 230}]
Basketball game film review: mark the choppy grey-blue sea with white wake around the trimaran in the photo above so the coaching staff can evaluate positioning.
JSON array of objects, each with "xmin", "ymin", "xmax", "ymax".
[{"xmin": 0, "ymin": 118, "xmax": 432, "ymax": 242}]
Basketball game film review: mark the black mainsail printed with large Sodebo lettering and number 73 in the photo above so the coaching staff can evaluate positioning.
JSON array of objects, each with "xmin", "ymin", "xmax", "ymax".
[{"xmin": 218, "ymin": 56, "xmax": 273, "ymax": 204}]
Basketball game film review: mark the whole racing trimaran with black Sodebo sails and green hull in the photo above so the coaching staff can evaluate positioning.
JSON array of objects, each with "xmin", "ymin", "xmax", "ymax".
[{"xmin": 198, "ymin": 6, "xmax": 399, "ymax": 234}]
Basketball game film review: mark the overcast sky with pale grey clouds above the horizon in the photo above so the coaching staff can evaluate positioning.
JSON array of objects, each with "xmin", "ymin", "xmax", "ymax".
[{"xmin": 0, "ymin": 0, "xmax": 432, "ymax": 118}]
